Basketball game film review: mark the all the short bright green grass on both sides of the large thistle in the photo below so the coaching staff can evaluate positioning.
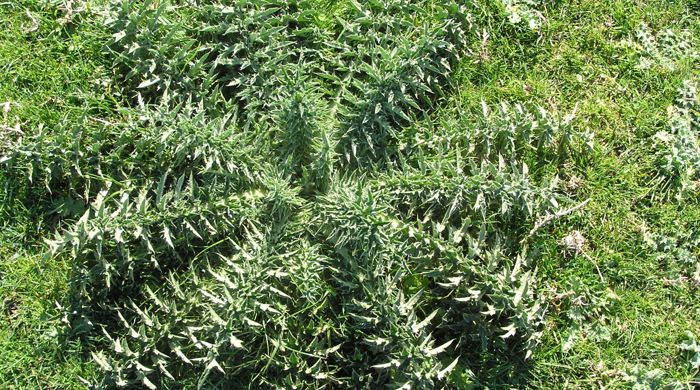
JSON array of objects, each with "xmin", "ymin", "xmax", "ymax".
[{"xmin": 0, "ymin": 0, "xmax": 700, "ymax": 388}]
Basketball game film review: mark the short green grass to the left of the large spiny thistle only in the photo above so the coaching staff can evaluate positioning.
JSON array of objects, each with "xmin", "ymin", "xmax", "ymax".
[{"xmin": 0, "ymin": 1, "xmax": 113, "ymax": 389}]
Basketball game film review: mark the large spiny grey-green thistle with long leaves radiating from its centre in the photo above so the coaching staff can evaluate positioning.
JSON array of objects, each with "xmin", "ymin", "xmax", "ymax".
[{"xmin": 3, "ymin": 0, "xmax": 592, "ymax": 388}]
